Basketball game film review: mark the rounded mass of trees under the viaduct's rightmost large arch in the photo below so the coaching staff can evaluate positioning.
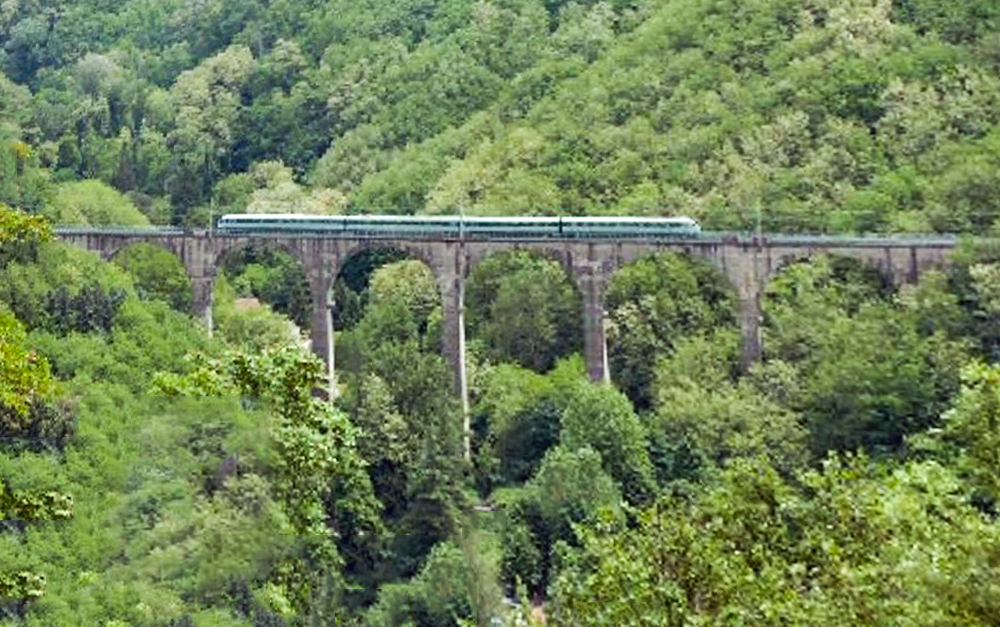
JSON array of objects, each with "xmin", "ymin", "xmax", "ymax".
[{"xmin": 752, "ymin": 255, "xmax": 964, "ymax": 457}]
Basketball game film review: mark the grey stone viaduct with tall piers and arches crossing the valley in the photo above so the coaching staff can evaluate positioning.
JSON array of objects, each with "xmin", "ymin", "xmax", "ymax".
[{"xmin": 57, "ymin": 228, "xmax": 957, "ymax": 401}]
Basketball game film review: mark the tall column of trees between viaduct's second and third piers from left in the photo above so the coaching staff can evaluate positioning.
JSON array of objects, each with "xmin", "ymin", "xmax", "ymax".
[{"xmin": 336, "ymin": 251, "xmax": 466, "ymax": 602}]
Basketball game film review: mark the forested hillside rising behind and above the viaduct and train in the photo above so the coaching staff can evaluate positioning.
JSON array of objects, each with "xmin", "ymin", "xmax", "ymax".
[{"xmin": 0, "ymin": 0, "xmax": 1000, "ymax": 232}]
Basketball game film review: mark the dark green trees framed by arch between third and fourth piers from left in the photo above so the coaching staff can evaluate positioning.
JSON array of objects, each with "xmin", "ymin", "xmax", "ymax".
[{"xmin": 464, "ymin": 249, "xmax": 583, "ymax": 372}]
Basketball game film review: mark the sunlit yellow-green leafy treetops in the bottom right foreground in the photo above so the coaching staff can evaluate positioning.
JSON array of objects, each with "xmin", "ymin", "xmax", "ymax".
[{"xmin": 550, "ymin": 458, "xmax": 998, "ymax": 625}]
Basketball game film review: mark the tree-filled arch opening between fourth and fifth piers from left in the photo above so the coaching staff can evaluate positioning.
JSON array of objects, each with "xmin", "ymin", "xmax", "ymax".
[{"xmin": 604, "ymin": 251, "xmax": 741, "ymax": 411}]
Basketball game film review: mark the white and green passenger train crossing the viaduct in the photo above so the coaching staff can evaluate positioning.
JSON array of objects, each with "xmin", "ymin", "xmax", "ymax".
[{"xmin": 216, "ymin": 213, "xmax": 701, "ymax": 239}]
